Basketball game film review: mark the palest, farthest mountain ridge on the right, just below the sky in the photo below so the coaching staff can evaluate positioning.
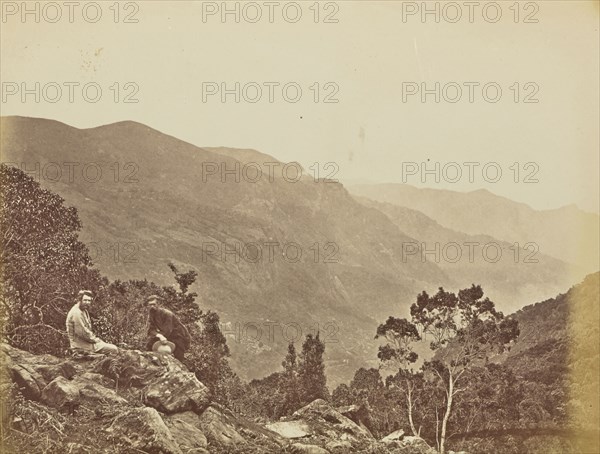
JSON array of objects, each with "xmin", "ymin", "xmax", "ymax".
[{"xmin": 348, "ymin": 184, "xmax": 600, "ymax": 274}]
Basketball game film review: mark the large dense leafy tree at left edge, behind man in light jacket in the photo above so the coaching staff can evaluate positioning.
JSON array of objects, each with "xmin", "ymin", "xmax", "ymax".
[{"xmin": 0, "ymin": 164, "xmax": 102, "ymax": 354}]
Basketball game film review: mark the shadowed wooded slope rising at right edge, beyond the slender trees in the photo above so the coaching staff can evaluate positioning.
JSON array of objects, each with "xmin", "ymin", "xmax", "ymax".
[{"xmin": 496, "ymin": 273, "xmax": 600, "ymax": 430}]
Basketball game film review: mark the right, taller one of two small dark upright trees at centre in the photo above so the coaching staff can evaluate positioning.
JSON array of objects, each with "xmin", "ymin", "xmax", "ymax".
[{"xmin": 298, "ymin": 332, "xmax": 329, "ymax": 404}]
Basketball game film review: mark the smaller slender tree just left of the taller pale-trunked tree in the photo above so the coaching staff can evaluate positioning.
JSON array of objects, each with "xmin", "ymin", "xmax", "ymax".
[{"xmin": 375, "ymin": 317, "xmax": 421, "ymax": 436}]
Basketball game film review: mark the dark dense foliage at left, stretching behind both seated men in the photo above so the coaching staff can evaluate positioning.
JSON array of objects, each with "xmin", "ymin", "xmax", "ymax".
[{"xmin": 0, "ymin": 165, "xmax": 237, "ymax": 397}]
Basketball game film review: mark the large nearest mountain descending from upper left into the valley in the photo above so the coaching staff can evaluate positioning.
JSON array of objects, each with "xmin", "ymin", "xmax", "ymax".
[{"xmin": 1, "ymin": 117, "xmax": 449, "ymax": 383}]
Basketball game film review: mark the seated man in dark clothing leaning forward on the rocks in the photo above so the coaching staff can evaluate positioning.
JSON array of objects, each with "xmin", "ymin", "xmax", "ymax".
[{"xmin": 146, "ymin": 295, "xmax": 191, "ymax": 361}]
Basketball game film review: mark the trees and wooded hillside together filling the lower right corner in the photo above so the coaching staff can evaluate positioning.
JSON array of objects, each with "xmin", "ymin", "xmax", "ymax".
[{"xmin": 332, "ymin": 273, "xmax": 600, "ymax": 454}]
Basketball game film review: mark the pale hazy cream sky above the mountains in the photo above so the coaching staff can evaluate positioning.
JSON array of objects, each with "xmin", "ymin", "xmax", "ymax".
[{"xmin": 1, "ymin": 1, "xmax": 600, "ymax": 211}]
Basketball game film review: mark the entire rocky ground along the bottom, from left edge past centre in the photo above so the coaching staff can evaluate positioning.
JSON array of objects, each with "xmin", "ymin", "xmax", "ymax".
[{"xmin": 0, "ymin": 344, "xmax": 435, "ymax": 454}]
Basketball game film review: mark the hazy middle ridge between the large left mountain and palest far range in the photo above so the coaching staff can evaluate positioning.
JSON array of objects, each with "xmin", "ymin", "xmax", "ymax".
[{"xmin": 356, "ymin": 197, "xmax": 573, "ymax": 312}]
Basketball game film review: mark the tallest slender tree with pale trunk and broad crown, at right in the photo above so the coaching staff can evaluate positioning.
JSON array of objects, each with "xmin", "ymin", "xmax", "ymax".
[{"xmin": 410, "ymin": 285, "xmax": 519, "ymax": 454}]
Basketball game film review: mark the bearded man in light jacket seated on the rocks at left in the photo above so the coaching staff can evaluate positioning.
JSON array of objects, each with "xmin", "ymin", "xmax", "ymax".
[{"xmin": 67, "ymin": 290, "xmax": 119, "ymax": 355}]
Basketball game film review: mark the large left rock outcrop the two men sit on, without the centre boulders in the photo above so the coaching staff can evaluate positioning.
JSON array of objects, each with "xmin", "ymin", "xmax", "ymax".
[{"xmin": 0, "ymin": 344, "xmax": 291, "ymax": 454}]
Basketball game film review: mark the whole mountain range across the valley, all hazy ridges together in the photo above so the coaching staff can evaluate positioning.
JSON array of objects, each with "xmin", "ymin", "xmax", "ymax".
[{"xmin": 1, "ymin": 117, "xmax": 597, "ymax": 385}]
